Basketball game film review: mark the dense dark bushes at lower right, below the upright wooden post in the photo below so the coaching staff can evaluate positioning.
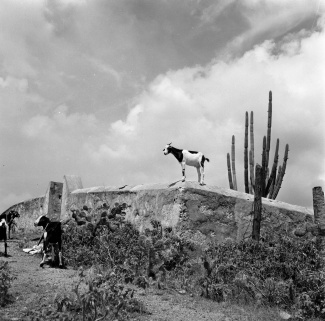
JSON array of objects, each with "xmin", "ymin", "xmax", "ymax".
[{"xmin": 199, "ymin": 236, "xmax": 325, "ymax": 317}]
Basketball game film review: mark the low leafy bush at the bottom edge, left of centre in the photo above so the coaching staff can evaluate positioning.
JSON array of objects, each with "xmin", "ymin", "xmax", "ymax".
[{"xmin": 25, "ymin": 267, "xmax": 145, "ymax": 321}]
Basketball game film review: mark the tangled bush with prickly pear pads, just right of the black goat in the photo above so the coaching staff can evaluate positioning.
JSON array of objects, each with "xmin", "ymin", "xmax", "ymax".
[{"xmin": 63, "ymin": 204, "xmax": 195, "ymax": 287}]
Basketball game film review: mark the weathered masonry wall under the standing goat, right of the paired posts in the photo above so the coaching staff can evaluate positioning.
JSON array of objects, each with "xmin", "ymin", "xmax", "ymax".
[{"xmin": 67, "ymin": 182, "xmax": 313, "ymax": 244}]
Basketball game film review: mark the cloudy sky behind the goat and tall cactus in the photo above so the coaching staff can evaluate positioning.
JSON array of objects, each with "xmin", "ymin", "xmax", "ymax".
[{"xmin": 0, "ymin": 0, "xmax": 325, "ymax": 212}]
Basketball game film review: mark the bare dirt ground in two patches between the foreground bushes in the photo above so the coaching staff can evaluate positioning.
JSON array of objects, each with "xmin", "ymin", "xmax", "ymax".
[{"xmin": 0, "ymin": 235, "xmax": 278, "ymax": 321}]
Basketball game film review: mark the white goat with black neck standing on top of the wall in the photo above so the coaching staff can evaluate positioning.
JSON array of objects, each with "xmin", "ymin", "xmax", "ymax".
[{"xmin": 163, "ymin": 143, "xmax": 209, "ymax": 185}]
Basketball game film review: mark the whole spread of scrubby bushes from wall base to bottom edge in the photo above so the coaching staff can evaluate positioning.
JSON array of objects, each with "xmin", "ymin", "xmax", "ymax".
[{"xmin": 10, "ymin": 201, "xmax": 325, "ymax": 320}]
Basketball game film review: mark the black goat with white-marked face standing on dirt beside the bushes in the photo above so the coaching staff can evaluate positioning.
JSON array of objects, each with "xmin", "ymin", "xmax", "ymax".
[{"xmin": 34, "ymin": 215, "xmax": 63, "ymax": 268}]
